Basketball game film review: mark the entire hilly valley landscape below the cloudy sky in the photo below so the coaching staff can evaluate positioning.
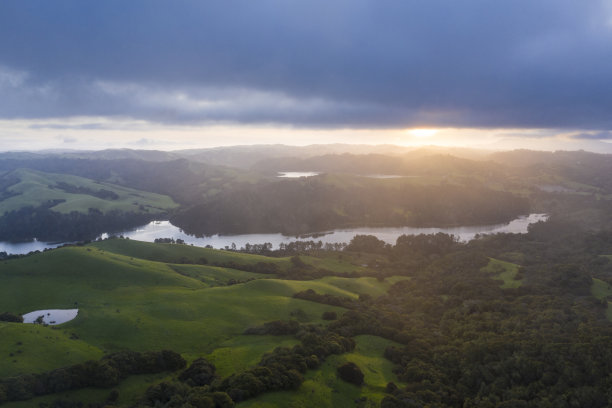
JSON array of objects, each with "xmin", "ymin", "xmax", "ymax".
[{"xmin": 0, "ymin": 145, "xmax": 612, "ymax": 408}]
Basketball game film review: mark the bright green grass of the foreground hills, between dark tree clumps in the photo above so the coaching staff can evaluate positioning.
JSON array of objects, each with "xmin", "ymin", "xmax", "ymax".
[{"xmin": 0, "ymin": 239, "xmax": 405, "ymax": 408}]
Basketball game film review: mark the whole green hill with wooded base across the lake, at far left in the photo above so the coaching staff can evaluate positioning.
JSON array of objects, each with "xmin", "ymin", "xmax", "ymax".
[{"xmin": 0, "ymin": 169, "xmax": 178, "ymax": 242}]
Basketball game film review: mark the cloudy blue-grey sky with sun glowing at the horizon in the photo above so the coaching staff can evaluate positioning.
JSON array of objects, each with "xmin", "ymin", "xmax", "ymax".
[{"xmin": 0, "ymin": 0, "xmax": 612, "ymax": 152}]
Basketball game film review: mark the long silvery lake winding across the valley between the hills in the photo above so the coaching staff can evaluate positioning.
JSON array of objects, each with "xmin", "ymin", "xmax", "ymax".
[{"xmin": 0, "ymin": 214, "xmax": 548, "ymax": 254}]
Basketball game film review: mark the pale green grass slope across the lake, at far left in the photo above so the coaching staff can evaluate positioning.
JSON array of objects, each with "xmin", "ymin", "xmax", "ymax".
[{"xmin": 0, "ymin": 169, "xmax": 178, "ymax": 214}]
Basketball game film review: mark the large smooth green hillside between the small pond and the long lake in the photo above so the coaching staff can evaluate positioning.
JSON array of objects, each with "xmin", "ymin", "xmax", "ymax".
[{"xmin": 0, "ymin": 247, "xmax": 344, "ymax": 353}]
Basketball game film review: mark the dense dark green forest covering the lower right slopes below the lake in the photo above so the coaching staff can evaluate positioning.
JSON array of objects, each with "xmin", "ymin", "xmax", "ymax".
[{"xmin": 331, "ymin": 226, "xmax": 612, "ymax": 407}]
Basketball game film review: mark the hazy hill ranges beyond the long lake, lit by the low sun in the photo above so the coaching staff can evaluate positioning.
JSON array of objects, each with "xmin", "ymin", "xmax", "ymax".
[{"xmin": 0, "ymin": 144, "xmax": 612, "ymax": 241}]
